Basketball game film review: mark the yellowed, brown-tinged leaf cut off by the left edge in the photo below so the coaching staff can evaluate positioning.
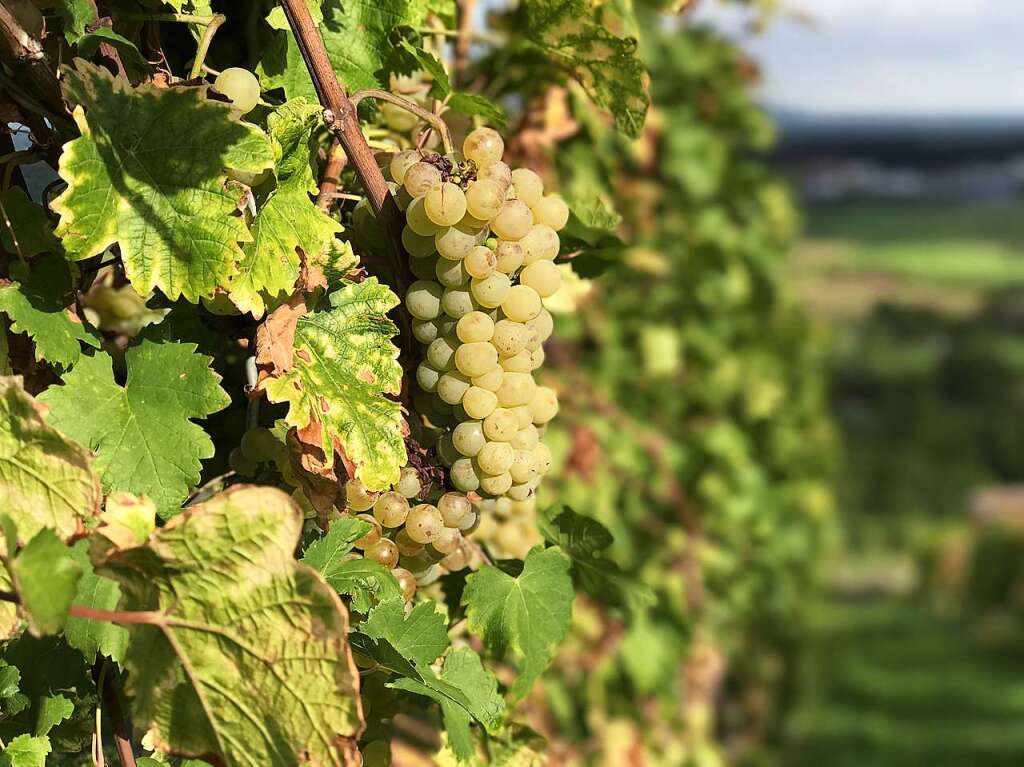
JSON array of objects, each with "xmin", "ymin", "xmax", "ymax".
[{"xmin": 0, "ymin": 377, "xmax": 101, "ymax": 541}]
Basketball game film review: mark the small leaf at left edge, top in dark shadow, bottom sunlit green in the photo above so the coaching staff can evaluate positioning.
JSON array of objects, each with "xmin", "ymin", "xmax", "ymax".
[{"xmin": 0, "ymin": 255, "xmax": 101, "ymax": 368}]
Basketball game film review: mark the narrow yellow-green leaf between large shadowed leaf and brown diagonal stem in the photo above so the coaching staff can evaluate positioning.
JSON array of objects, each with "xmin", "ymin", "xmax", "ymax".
[{"xmin": 230, "ymin": 98, "xmax": 341, "ymax": 317}]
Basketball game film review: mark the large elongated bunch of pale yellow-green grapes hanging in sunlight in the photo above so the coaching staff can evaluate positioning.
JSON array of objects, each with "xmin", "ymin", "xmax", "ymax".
[{"xmin": 390, "ymin": 128, "xmax": 568, "ymax": 501}]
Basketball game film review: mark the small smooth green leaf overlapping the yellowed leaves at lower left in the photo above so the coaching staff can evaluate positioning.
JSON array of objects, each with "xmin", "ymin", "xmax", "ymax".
[{"xmin": 6, "ymin": 527, "xmax": 82, "ymax": 637}]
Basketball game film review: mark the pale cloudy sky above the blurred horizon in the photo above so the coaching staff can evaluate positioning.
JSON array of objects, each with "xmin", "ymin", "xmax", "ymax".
[{"xmin": 697, "ymin": 0, "xmax": 1024, "ymax": 117}]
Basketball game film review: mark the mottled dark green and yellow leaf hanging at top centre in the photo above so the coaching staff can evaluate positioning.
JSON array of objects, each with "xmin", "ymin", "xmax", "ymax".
[{"xmin": 523, "ymin": 0, "xmax": 650, "ymax": 138}]
